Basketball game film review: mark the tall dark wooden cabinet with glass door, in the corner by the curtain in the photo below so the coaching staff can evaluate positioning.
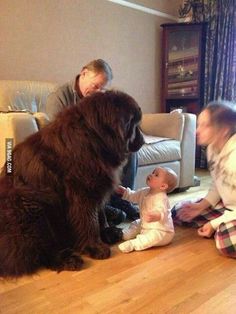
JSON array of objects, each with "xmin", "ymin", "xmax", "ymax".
[{"xmin": 161, "ymin": 23, "xmax": 206, "ymax": 114}]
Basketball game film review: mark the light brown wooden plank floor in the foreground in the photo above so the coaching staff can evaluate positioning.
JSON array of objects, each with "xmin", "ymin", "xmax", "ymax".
[{"xmin": 0, "ymin": 171, "xmax": 236, "ymax": 314}]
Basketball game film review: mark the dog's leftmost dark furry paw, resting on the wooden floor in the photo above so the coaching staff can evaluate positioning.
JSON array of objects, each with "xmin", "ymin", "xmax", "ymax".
[{"xmin": 50, "ymin": 249, "xmax": 84, "ymax": 272}]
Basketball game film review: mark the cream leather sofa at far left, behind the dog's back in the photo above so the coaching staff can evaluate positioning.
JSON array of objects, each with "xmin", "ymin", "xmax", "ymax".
[{"xmin": 0, "ymin": 80, "xmax": 57, "ymax": 168}]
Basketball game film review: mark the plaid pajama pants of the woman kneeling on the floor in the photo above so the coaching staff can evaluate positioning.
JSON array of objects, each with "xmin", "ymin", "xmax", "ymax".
[{"xmin": 172, "ymin": 200, "xmax": 236, "ymax": 258}]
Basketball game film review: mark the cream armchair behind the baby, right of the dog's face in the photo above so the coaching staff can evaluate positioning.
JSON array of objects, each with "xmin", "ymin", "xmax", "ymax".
[{"xmin": 135, "ymin": 112, "xmax": 196, "ymax": 191}]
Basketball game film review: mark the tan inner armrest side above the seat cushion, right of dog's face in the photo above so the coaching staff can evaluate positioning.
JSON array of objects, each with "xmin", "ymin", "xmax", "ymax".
[{"xmin": 141, "ymin": 112, "xmax": 185, "ymax": 141}]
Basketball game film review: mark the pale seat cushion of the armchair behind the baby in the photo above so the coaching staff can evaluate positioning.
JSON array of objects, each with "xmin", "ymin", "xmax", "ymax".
[{"xmin": 138, "ymin": 139, "xmax": 181, "ymax": 166}]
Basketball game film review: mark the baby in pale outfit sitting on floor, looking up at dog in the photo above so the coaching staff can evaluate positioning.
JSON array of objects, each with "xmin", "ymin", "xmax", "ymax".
[{"xmin": 116, "ymin": 167, "xmax": 178, "ymax": 253}]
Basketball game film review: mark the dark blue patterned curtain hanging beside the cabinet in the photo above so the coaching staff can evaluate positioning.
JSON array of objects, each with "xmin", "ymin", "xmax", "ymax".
[{"xmin": 200, "ymin": 0, "xmax": 236, "ymax": 168}]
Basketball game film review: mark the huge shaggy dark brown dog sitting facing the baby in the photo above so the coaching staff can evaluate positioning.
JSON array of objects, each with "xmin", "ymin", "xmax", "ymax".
[{"xmin": 0, "ymin": 91, "xmax": 143, "ymax": 277}]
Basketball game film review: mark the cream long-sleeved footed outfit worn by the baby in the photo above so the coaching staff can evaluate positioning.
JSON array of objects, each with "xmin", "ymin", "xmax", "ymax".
[{"xmin": 119, "ymin": 187, "xmax": 174, "ymax": 253}]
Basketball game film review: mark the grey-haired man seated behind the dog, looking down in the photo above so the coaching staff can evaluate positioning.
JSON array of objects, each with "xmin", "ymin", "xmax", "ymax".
[{"xmin": 46, "ymin": 59, "xmax": 139, "ymax": 229}]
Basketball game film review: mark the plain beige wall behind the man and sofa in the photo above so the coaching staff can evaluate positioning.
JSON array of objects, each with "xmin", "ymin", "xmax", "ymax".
[{"xmin": 0, "ymin": 0, "xmax": 182, "ymax": 112}]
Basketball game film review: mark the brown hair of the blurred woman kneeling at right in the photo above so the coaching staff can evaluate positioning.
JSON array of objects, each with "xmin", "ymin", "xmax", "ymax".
[{"xmin": 203, "ymin": 101, "xmax": 236, "ymax": 136}]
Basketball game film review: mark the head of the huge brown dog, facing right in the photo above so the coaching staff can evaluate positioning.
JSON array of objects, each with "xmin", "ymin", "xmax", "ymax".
[{"xmin": 79, "ymin": 91, "xmax": 144, "ymax": 152}]
